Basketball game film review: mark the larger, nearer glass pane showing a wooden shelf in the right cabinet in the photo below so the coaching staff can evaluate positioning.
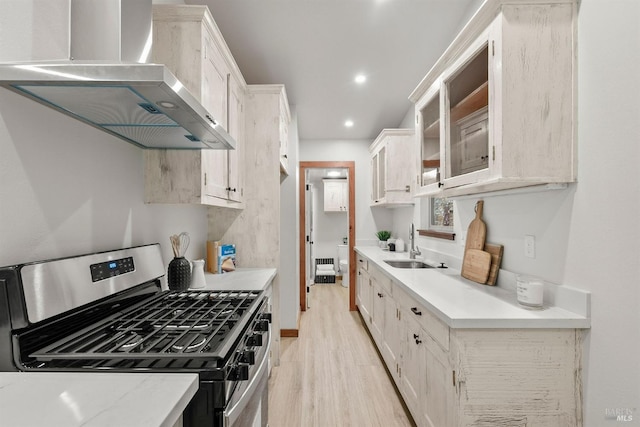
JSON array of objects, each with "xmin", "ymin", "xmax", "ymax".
[{"xmin": 446, "ymin": 46, "xmax": 489, "ymax": 178}]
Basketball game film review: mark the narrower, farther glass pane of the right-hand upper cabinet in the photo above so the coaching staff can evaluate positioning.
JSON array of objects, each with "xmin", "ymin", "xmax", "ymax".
[{"xmin": 420, "ymin": 92, "xmax": 440, "ymax": 186}]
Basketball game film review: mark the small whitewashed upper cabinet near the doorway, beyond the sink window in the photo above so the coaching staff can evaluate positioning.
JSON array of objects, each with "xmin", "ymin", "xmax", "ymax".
[{"xmin": 369, "ymin": 129, "xmax": 415, "ymax": 207}]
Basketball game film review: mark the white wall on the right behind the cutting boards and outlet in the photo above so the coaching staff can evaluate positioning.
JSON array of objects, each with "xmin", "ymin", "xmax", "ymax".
[{"xmin": 394, "ymin": 0, "xmax": 640, "ymax": 427}]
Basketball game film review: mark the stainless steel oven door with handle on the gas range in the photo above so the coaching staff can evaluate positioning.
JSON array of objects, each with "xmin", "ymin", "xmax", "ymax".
[{"xmin": 224, "ymin": 328, "xmax": 271, "ymax": 427}]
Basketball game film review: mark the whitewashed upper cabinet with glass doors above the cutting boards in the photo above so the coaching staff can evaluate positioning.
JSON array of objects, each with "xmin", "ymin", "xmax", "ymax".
[{"xmin": 410, "ymin": 0, "xmax": 576, "ymax": 196}]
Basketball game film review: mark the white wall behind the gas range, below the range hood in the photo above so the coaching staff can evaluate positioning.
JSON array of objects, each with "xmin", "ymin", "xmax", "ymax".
[{"xmin": 0, "ymin": 89, "xmax": 207, "ymax": 274}]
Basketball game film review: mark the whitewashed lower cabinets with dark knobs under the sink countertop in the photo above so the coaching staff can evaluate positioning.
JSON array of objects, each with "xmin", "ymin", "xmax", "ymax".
[{"xmin": 357, "ymin": 260, "xmax": 582, "ymax": 427}]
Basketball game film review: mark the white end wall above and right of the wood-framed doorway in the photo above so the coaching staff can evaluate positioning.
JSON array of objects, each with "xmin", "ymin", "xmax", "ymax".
[{"xmin": 300, "ymin": 140, "xmax": 393, "ymax": 245}]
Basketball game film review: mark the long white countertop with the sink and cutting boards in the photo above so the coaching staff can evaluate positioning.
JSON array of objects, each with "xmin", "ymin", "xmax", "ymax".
[{"xmin": 355, "ymin": 246, "xmax": 590, "ymax": 328}]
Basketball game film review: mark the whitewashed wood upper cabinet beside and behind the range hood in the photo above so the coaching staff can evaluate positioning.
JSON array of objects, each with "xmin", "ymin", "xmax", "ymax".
[{"xmin": 145, "ymin": 5, "xmax": 246, "ymax": 208}]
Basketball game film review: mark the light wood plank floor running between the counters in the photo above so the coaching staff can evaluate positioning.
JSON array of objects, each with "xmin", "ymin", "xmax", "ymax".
[{"xmin": 269, "ymin": 284, "xmax": 414, "ymax": 427}]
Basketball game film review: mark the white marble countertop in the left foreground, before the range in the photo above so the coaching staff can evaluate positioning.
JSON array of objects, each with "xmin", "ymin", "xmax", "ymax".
[{"xmin": 0, "ymin": 372, "xmax": 198, "ymax": 427}]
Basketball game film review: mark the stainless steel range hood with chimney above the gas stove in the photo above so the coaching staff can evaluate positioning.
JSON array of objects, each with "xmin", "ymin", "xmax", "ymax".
[{"xmin": 0, "ymin": 0, "xmax": 236, "ymax": 149}]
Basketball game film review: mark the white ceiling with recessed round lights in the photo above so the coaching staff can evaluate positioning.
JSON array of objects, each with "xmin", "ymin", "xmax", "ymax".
[{"xmin": 185, "ymin": 0, "xmax": 482, "ymax": 140}]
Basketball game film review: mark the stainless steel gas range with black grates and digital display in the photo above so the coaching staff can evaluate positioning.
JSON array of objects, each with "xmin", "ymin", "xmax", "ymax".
[{"xmin": 0, "ymin": 244, "xmax": 271, "ymax": 427}]
